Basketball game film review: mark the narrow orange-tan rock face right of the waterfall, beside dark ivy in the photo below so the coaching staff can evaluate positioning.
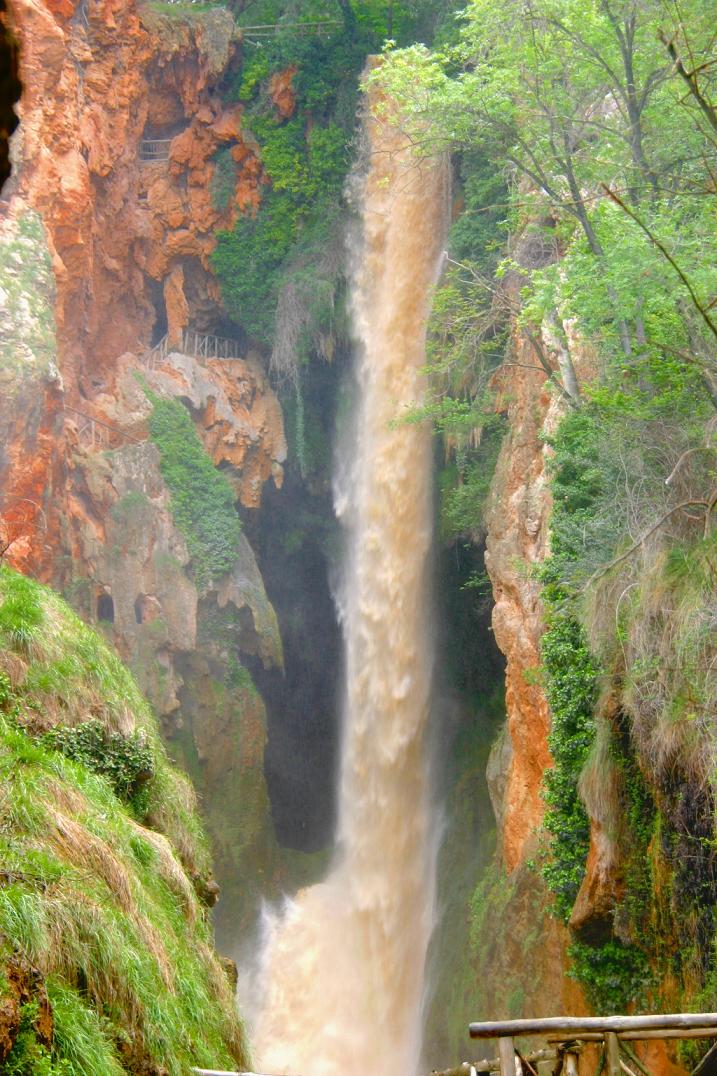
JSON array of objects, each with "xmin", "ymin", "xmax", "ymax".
[{"xmin": 481, "ymin": 260, "xmax": 589, "ymax": 1017}]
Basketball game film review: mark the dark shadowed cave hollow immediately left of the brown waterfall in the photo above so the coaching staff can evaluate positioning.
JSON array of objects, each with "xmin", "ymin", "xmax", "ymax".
[{"xmin": 247, "ymin": 466, "xmax": 342, "ymax": 852}]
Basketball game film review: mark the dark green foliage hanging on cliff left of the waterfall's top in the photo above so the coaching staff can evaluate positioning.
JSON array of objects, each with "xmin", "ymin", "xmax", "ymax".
[{"xmin": 212, "ymin": 0, "xmax": 449, "ymax": 361}]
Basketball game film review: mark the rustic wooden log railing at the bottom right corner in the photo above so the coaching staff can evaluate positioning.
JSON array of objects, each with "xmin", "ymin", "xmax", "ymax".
[{"xmin": 434, "ymin": 1013, "xmax": 717, "ymax": 1076}]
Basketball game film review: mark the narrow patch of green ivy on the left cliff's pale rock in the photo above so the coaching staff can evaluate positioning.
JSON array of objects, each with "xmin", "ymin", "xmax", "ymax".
[{"xmin": 150, "ymin": 397, "xmax": 241, "ymax": 590}]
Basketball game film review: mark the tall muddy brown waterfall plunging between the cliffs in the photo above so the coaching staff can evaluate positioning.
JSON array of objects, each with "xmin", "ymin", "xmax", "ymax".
[{"xmin": 248, "ymin": 90, "xmax": 448, "ymax": 1076}]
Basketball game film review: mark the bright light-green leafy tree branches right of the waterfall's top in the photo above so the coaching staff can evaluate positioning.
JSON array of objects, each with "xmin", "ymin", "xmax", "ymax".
[{"xmin": 371, "ymin": 0, "xmax": 717, "ymax": 404}]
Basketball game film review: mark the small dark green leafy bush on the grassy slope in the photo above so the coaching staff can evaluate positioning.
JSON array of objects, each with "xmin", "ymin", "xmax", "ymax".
[{"xmin": 43, "ymin": 721, "xmax": 155, "ymax": 804}]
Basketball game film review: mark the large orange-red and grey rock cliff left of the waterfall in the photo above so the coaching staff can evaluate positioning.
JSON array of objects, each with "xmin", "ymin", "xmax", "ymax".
[{"xmin": 0, "ymin": 0, "xmax": 292, "ymax": 937}]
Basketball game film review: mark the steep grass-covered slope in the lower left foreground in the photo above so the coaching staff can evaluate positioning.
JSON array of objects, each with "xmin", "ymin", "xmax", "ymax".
[{"xmin": 0, "ymin": 566, "xmax": 247, "ymax": 1076}]
